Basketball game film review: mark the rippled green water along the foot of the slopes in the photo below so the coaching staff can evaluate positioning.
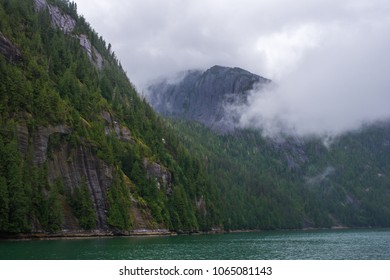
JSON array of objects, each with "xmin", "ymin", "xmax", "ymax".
[{"xmin": 0, "ymin": 229, "xmax": 390, "ymax": 260}]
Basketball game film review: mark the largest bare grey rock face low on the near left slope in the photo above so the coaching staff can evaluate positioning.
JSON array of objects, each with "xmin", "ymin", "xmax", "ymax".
[{"xmin": 17, "ymin": 123, "xmax": 109, "ymax": 231}]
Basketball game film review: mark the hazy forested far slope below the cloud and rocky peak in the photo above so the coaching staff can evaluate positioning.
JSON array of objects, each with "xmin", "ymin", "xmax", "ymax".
[{"xmin": 171, "ymin": 121, "xmax": 390, "ymax": 229}]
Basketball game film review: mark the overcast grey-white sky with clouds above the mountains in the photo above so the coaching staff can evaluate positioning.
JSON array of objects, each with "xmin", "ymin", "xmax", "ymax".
[{"xmin": 75, "ymin": 0, "xmax": 390, "ymax": 134}]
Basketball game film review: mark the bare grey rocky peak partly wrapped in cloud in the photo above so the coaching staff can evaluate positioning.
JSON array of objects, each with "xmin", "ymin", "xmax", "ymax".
[{"xmin": 147, "ymin": 66, "xmax": 270, "ymax": 132}]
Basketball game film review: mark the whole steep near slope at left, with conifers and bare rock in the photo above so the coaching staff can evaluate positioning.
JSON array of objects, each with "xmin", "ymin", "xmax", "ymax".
[{"xmin": 0, "ymin": 0, "xmax": 213, "ymax": 236}]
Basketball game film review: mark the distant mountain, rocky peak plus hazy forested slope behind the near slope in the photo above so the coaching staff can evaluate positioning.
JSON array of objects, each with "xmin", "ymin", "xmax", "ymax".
[{"xmin": 149, "ymin": 66, "xmax": 390, "ymax": 229}]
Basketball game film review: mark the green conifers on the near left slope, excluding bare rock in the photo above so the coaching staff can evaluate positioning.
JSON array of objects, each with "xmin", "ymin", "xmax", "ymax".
[{"xmin": 0, "ymin": 0, "xmax": 210, "ymax": 233}]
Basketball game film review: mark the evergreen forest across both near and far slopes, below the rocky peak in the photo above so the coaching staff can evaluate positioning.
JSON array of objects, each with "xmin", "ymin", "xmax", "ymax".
[{"xmin": 0, "ymin": 0, "xmax": 390, "ymax": 235}]
